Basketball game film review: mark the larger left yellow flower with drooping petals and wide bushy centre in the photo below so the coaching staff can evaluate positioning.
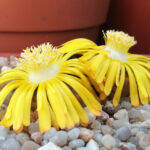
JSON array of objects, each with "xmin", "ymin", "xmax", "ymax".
[{"xmin": 0, "ymin": 44, "xmax": 101, "ymax": 132}]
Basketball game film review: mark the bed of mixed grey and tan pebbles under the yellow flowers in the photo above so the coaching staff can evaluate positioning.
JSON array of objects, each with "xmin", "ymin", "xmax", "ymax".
[{"xmin": 0, "ymin": 56, "xmax": 150, "ymax": 150}]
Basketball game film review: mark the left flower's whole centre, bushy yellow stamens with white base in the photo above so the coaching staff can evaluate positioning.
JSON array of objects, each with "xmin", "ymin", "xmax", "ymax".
[{"xmin": 18, "ymin": 43, "xmax": 61, "ymax": 83}]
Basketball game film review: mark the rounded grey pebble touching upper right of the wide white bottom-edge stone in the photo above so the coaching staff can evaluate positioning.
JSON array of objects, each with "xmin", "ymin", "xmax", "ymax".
[{"xmin": 49, "ymin": 131, "xmax": 68, "ymax": 146}]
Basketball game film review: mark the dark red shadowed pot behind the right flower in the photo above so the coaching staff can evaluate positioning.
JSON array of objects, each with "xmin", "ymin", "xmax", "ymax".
[{"xmin": 108, "ymin": 0, "xmax": 150, "ymax": 54}]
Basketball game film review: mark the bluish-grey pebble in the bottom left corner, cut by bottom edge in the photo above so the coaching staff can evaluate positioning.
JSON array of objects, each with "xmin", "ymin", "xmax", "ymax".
[{"xmin": 1, "ymin": 138, "xmax": 21, "ymax": 150}]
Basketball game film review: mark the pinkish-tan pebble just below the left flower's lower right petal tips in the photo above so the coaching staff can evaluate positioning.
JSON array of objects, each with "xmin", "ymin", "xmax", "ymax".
[{"xmin": 79, "ymin": 128, "xmax": 94, "ymax": 142}]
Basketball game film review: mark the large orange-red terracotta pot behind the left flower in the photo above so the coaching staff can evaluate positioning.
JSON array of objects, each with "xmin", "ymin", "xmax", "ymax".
[{"xmin": 0, "ymin": 0, "xmax": 109, "ymax": 54}]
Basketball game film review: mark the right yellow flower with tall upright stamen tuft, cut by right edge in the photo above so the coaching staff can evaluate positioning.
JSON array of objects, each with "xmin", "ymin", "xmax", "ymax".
[{"xmin": 81, "ymin": 30, "xmax": 150, "ymax": 106}]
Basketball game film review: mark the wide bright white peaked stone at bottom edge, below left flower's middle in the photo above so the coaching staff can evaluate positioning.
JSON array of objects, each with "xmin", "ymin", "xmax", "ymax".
[{"xmin": 38, "ymin": 142, "xmax": 62, "ymax": 150}]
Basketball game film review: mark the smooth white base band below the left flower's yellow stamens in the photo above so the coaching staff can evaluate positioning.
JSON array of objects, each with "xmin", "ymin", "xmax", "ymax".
[{"xmin": 29, "ymin": 64, "xmax": 60, "ymax": 83}]
